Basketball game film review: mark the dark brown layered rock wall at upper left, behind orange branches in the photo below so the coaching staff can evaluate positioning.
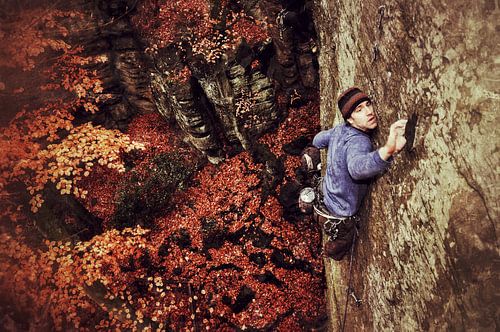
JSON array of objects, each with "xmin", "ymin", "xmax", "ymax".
[{"xmin": 90, "ymin": 0, "xmax": 154, "ymax": 128}]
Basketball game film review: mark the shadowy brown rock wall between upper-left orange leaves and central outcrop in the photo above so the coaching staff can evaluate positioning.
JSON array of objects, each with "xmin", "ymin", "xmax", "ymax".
[{"xmin": 68, "ymin": 0, "xmax": 155, "ymax": 129}]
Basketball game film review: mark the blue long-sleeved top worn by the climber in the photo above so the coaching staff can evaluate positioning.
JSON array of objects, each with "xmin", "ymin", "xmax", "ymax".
[{"xmin": 313, "ymin": 123, "xmax": 391, "ymax": 217}]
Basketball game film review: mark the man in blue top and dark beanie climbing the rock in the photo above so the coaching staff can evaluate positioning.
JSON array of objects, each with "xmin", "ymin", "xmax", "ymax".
[{"xmin": 313, "ymin": 87, "xmax": 407, "ymax": 260}]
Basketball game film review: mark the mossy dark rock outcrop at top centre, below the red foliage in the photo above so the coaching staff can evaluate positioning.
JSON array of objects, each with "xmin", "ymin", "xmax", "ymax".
[{"xmin": 143, "ymin": 1, "xmax": 318, "ymax": 163}]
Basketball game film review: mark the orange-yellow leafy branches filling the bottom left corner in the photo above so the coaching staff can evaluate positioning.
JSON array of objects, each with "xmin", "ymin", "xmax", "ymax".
[{"xmin": 0, "ymin": 227, "xmax": 152, "ymax": 330}]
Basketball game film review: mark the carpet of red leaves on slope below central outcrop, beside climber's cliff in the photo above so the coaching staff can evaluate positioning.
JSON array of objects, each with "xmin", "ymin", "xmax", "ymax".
[{"xmin": 145, "ymin": 153, "xmax": 324, "ymax": 330}]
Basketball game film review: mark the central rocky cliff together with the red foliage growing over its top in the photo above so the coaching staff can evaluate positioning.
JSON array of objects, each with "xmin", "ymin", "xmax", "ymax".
[{"xmin": 137, "ymin": 0, "xmax": 318, "ymax": 163}]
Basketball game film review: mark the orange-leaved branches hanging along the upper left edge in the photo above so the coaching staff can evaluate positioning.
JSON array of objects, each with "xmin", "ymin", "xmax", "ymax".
[{"xmin": 0, "ymin": 5, "xmax": 139, "ymax": 212}]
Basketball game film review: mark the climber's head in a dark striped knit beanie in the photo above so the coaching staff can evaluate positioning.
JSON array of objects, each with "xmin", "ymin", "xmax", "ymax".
[{"xmin": 338, "ymin": 87, "xmax": 377, "ymax": 131}]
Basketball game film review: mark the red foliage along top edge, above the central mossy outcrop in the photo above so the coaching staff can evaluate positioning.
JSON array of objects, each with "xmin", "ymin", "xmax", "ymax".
[{"xmin": 132, "ymin": 0, "xmax": 269, "ymax": 63}]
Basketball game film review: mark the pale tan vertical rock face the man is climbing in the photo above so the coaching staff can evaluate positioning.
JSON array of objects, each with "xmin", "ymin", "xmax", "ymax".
[{"xmin": 315, "ymin": 0, "xmax": 500, "ymax": 331}]
